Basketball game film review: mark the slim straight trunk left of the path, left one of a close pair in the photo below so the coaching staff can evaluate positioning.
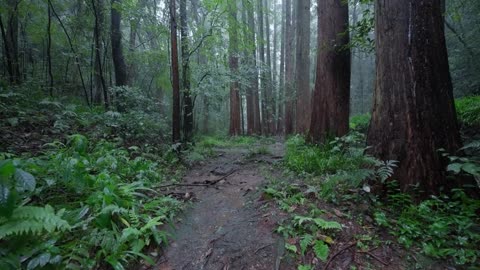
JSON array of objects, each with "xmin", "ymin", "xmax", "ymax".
[{"xmin": 170, "ymin": 0, "xmax": 181, "ymax": 143}]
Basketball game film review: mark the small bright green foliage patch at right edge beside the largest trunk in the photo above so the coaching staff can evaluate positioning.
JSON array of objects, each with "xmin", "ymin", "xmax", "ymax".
[{"xmin": 455, "ymin": 96, "xmax": 480, "ymax": 127}]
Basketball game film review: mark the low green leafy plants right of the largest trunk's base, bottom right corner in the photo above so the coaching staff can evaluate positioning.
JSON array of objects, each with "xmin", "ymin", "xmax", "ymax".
[{"xmin": 388, "ymin": 190, "xmax": 480, "ymax": 265}]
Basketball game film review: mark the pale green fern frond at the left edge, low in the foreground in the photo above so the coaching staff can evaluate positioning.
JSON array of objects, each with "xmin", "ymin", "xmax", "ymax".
[{"xmin": 0, "ymin": 205, "xmax": 70, "ymax": 240}]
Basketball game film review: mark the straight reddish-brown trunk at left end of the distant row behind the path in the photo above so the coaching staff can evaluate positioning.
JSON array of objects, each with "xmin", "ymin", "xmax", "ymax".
[{"xmin": 228, "ymin": 1, "xmax": 242, "ymax": 136}]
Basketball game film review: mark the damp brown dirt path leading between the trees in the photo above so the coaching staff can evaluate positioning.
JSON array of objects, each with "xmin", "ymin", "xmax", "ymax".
[{"xmin": 158, "ymin": 142, "xmax": 290, "ymax": 270}]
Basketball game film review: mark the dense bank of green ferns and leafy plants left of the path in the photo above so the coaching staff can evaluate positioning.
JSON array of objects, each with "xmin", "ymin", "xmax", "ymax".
[{"xmin": 0, "ymin": 134, "xmax": 182, "ymax": 269}]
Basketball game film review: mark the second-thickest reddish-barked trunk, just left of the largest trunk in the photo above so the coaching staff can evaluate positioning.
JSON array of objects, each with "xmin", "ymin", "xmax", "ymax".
[{"xmin": 309, "ymin": 0, "xmax": 350, "ymax": 143}]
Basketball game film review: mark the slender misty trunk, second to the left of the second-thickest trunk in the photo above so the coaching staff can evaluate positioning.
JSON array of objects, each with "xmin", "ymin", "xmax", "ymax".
[{"xmin": 285, "ymin": 0, "xmax": 295, "ymax": 135}]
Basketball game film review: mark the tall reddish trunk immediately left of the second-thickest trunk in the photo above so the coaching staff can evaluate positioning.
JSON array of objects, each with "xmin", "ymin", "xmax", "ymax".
[{"xmin": 295, "ymin": 0, "xmax": 311, "ymax": 134}]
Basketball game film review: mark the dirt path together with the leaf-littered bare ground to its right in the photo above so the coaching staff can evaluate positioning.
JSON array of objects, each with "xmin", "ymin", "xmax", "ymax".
[{"xmin": 150, "ymin": 141, "xmax": 438, "ymax": 270}]
